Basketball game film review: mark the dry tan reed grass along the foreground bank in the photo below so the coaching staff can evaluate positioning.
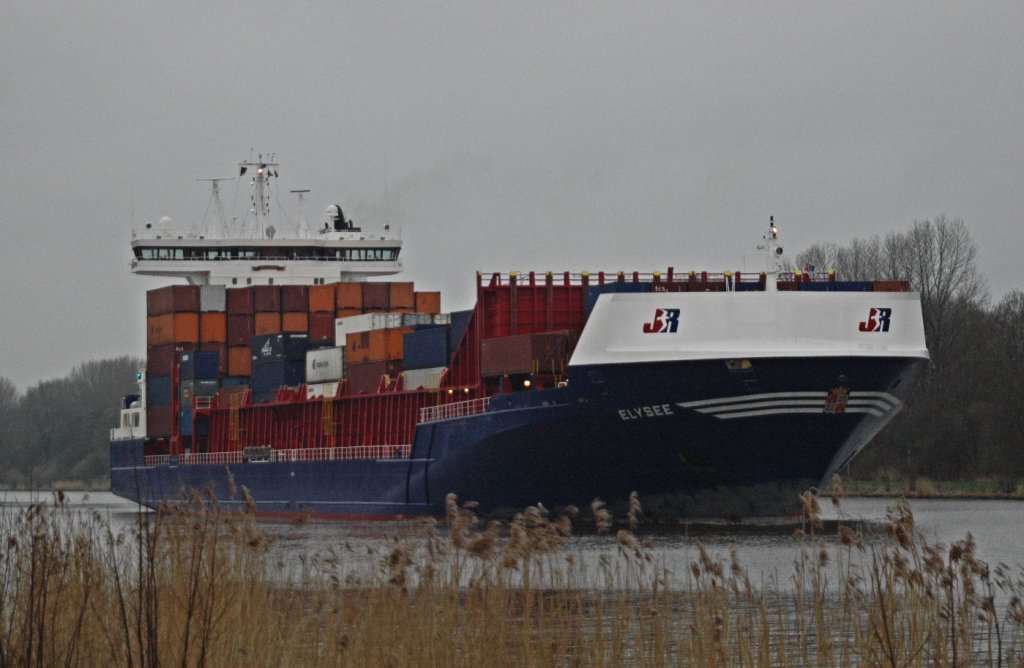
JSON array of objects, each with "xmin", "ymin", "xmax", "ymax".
[{"xmin": 0, "ymin": 488, "xmax": 1024, "ymax": 667}]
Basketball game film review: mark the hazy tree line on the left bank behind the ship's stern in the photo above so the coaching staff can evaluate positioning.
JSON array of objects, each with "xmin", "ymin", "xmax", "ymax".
[{"xmin": 0, "ymin": 357, "xmax": 142, "ymax": 489}]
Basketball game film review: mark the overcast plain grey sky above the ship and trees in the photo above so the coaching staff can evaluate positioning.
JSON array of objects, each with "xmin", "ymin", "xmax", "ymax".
[{"xmin": 0, "ymin": 0, "xmax": 1024, "ymax": 389}]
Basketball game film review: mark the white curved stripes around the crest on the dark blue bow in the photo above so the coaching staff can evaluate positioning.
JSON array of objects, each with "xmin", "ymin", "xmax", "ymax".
[{"xmin": 678, "ymin": 391, "xmax": 902, "ymax": 420}]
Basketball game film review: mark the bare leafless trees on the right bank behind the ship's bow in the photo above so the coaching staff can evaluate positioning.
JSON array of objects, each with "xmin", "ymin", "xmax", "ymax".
[{"xmin": 797, "ymin": 216, "xmax": 1024, "ymax": 492}]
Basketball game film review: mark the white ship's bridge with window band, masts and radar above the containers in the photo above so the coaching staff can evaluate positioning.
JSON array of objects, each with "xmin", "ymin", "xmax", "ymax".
[{"xmin": 131, "ymin": 156, "xmax": 401, "ymax": 286}]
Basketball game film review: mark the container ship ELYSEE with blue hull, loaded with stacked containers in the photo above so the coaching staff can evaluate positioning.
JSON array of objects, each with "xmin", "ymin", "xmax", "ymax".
[{"xmin": 111, "ymin": 157, "xmax": 928, "ymax": 518}]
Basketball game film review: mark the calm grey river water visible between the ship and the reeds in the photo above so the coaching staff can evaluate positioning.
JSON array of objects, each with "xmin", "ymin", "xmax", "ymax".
[{"xmin": 0, "ymin": 492, "xmax": 1024, "ymax": 585}]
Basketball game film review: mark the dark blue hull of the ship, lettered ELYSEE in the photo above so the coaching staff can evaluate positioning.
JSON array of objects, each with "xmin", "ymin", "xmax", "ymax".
[{"xmin": 111, "ymin": 358, "xmax": 925, "ymax": 517}]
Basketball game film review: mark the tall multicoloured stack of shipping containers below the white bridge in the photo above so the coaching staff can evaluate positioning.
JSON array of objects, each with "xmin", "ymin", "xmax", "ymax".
[{"xmin": 146, "ymin": 283, "xmax": 440, "ymax": 439}]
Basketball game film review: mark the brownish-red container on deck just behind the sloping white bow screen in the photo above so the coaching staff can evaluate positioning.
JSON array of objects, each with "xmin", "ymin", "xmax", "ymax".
[{"xmin": 480, "ymin": 332, "xmax": 570, "ymax": 377}]
